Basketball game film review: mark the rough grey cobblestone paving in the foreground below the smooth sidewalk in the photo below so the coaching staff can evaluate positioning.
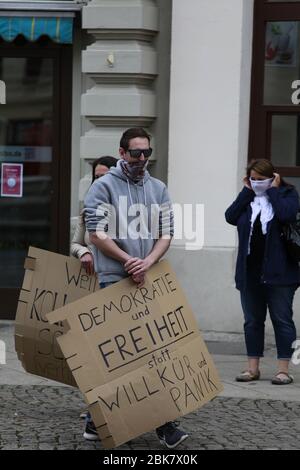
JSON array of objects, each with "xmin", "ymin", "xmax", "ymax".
[{"xmin": 0, "ymin": 385, "xmax": 300, "ymax": 450}]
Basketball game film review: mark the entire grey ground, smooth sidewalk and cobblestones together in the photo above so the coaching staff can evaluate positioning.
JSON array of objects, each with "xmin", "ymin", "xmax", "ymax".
[{"xmin": 0, "ymin": 322, "xmax": 300, "ymax": 451}]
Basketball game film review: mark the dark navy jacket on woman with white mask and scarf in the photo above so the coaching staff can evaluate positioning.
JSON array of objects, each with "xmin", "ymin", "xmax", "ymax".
[{"xmin": 225, "ymin": 186, "xmax": 300, "ymax": 290}]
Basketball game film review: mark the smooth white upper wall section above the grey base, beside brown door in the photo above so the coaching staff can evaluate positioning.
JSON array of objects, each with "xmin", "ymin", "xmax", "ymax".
[{"xmin": 169, "ymin": 0, "xmax": 253, "ymax": 249}]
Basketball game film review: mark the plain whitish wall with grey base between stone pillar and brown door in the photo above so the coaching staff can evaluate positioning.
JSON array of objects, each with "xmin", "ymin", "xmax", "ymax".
[{"xmin": 168, "ymin": 0, "xmax": 264, "ymax": 332}]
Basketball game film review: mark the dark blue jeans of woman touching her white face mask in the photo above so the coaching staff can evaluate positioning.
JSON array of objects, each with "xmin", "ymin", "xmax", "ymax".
[{"xmin": 241, "ymin": 279, "xmax": 297, "ymax": 360}]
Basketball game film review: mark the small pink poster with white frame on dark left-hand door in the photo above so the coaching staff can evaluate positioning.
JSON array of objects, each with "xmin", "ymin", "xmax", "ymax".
[{"xmin": 1, "ymin": 163, "xmax": 23, "ymax": 197}]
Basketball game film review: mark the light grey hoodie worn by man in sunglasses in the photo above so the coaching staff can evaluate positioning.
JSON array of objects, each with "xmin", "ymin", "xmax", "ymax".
[{"xmin": 84, "ymin": 162, "xmax": 174, "ymax": 282}]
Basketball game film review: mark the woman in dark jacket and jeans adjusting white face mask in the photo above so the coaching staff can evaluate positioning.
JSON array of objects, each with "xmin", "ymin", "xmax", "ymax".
[{"xmin": 225, "ymin": 159, "xmax": 300, "ymax": 385}]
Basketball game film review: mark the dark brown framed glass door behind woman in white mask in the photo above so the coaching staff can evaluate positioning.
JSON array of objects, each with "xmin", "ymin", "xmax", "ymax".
[{"xmin": 249, "ymin": 0, "xmax": 300, "ymax": 176}]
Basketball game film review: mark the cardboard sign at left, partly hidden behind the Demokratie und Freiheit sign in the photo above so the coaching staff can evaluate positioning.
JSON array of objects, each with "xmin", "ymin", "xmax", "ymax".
[{"xmin": 15, "ymin": 247, "xmax": 99, "ymax": 386}]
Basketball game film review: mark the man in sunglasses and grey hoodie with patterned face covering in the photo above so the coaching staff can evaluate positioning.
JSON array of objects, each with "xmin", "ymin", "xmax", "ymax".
[{"xmin": 84, "ymin": 128, "xmax": 188, "ymax": 448}]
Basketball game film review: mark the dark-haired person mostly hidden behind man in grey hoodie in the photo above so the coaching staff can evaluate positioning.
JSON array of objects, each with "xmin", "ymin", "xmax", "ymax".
[{"xmin": 71, "ymin": 156, "xmax": 118, "ymax": 274}]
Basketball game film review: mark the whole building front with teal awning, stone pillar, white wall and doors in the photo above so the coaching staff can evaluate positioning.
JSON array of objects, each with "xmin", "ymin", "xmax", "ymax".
[{"xmin": 0, "ymin": 0, "xmax": 300, "ymax": 332}]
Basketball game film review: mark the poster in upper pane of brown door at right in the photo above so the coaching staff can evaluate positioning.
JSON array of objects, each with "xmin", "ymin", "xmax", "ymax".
[{"xmin": 265, "ymin": 21, "xmax": 298, "ymax": 67}]
